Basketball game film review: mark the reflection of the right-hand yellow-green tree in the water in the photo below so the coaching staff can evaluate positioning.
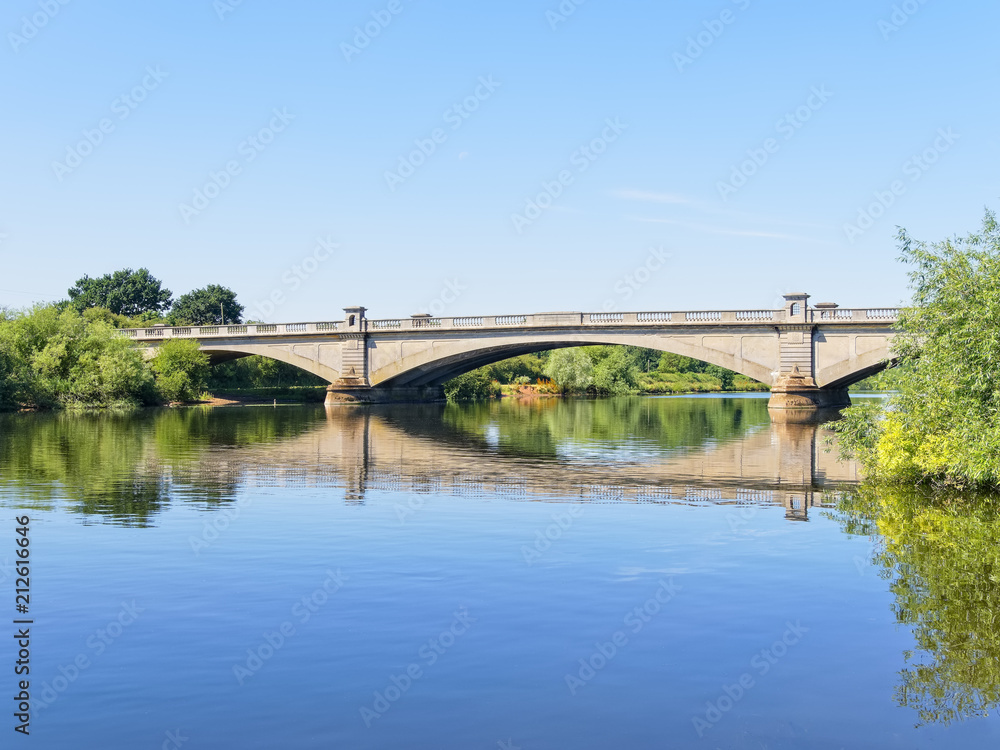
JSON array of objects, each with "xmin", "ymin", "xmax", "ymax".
[{"xmin": 844, "ymin": 487, "xmax": 1000, "ymax": 724}]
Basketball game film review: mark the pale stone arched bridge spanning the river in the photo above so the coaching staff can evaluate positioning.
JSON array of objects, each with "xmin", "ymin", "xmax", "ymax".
[{"xmin": 122, "ymin": 294, "xmax": 899, "ymax": 410}]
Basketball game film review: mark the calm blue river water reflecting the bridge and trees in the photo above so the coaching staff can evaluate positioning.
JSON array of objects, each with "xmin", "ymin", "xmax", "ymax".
[{"xmin": 0, "ymin": 396, "xmax": 1000, "ymax": 750}]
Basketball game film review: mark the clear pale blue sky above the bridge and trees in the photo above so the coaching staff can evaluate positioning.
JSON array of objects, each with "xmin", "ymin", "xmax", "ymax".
[{"xmin": 0, "ymin": 0, "xmax": 1000, "ymax": 321}]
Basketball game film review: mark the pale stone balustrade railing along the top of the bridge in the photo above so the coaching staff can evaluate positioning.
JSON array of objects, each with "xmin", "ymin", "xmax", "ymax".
[{"xmin": 121, "ymin": 307, "xmax": 899, "ymax": 340}]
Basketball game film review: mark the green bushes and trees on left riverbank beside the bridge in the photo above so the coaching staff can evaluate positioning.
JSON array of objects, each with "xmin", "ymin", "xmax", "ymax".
[{"xmin": 0, "ymin": 268, "xmax": 326, "ymax": 410}]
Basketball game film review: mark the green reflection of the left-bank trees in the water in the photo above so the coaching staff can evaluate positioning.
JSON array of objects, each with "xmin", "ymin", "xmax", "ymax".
[{"xmin": 0, "ymin": 408, "xmax": 317, "ymax": 526}]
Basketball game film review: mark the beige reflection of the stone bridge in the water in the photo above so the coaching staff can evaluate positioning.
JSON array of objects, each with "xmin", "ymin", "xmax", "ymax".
[{"xmin": 229, "ymin": 406, "xmax": 857, "ymax": 520}]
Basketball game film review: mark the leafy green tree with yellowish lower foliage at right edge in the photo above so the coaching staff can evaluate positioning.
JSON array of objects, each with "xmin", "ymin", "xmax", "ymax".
[{"xmin": 838, "ymin": 212, "xmax": 1000, "ymax": 486}]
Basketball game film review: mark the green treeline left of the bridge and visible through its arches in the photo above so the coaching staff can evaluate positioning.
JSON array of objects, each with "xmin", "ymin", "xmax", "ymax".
[{"xmin": 0, "ymin": 268, "xmax": 767, "ymax": 409}]
